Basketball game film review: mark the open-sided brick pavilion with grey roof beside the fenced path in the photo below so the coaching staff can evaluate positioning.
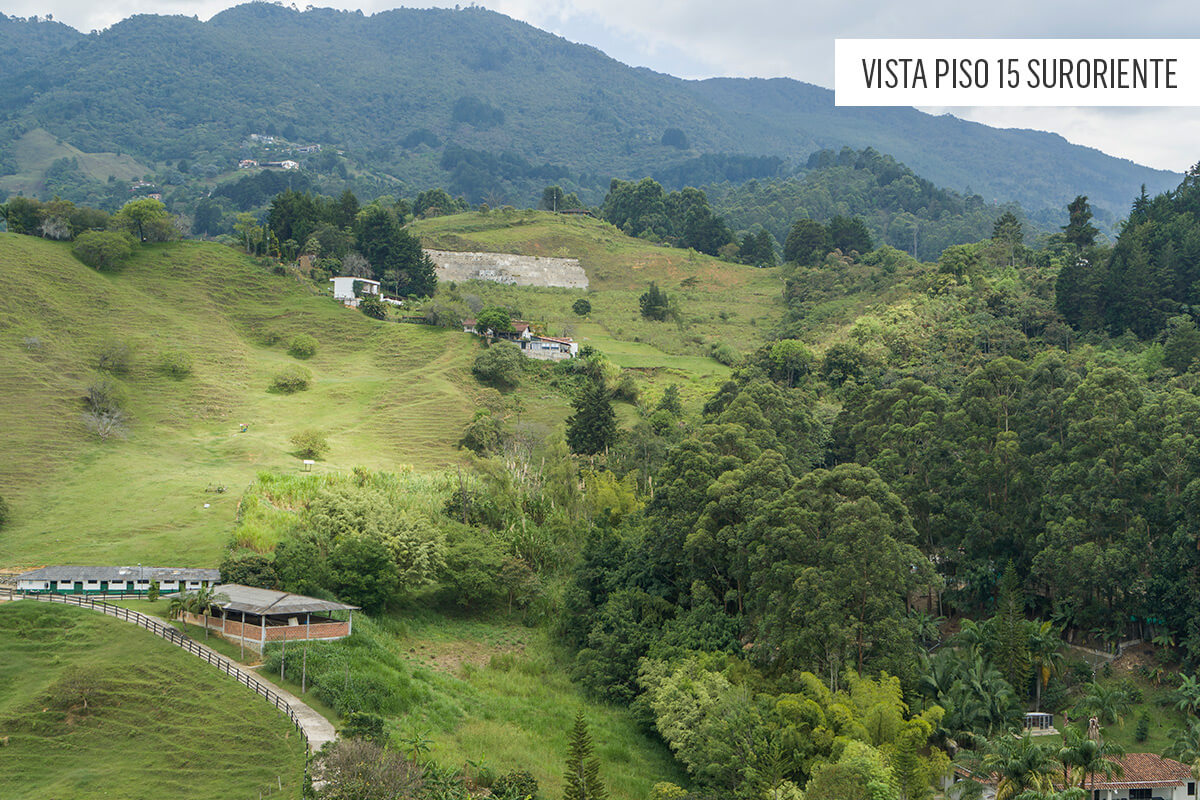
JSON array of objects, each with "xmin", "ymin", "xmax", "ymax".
[{"xmin": 177, "ymin": 583, "xmax": 359, "ymax": 650}]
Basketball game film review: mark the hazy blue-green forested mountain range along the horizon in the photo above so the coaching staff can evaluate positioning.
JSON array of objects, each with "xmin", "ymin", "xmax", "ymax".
[{"xmin": 0, "ymin": 2, "xmax": 1180, "ymax": 215}]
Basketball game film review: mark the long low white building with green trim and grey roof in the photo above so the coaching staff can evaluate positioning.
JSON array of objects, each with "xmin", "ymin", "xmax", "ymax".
[{"xmin": 17, "ymin": 566, "xmax": 221, "ymax": 595}]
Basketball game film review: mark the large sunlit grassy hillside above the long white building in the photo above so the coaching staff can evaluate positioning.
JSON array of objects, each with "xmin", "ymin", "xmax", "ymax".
[{"xmin": 0, "ymin": 234, "xmax": 569, "ymax": 567}]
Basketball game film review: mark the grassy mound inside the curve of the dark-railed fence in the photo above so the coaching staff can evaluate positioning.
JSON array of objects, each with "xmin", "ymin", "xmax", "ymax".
[{"xmin": 0, "ymin": 601, "xmax": 305, "ymax": 800}]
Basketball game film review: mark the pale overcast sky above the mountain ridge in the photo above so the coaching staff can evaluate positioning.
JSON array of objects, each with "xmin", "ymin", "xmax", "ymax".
[{"xmin": 11, "ymin": 0, "xmax": 1200, "ymax": 172}]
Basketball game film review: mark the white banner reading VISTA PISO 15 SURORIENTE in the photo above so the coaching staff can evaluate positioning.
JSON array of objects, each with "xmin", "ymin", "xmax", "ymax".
[{"xmin": 834, "ymin": 38, "xmax": 1200, "ymax": 107}]
